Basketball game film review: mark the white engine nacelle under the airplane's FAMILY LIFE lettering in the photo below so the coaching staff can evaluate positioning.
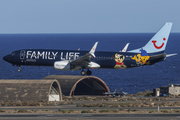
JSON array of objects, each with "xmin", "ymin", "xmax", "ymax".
[{"xmin": 54, "ymin": 61, "xmax": 70, "ymax": 70}]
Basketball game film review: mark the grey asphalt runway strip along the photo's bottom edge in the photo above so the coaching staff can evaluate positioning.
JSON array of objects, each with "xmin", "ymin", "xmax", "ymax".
[{"xmin": 0, "ymin": 114, "xmax": 180, "ymax": 120}]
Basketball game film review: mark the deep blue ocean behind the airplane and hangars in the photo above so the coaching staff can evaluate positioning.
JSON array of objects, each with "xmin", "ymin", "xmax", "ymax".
[{"xmin": 0, "ymin": 33, "xmax": 180, "ymax": 94}]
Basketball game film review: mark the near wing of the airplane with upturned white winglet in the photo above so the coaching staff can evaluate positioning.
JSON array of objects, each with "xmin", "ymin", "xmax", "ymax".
[{"xmin": 71, "ymin": 42, "xmax": 100, "ymax": 69}]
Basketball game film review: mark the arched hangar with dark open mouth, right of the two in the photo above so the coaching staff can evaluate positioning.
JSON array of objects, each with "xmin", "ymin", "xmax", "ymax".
[{"xmin": 43, "ymin": 75, "xmax": 109, "ymax": 96}]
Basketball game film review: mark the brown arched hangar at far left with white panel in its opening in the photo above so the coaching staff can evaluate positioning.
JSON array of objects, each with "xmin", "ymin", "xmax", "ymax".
[{"xmin": 0, "ymin": 80, "xmax": 62, "ymax": 101}]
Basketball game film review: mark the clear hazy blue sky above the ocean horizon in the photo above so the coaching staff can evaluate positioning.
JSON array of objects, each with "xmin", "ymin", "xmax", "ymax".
[{"xmin": 0, "ymin": 0, "xmax": 180, "ymax": 34}]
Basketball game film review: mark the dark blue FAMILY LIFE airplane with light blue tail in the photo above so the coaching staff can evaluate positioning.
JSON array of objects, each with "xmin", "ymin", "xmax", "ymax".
[{"xmin": 3, "ymin": 22, "xmax": 176, "ymax": 75}]
